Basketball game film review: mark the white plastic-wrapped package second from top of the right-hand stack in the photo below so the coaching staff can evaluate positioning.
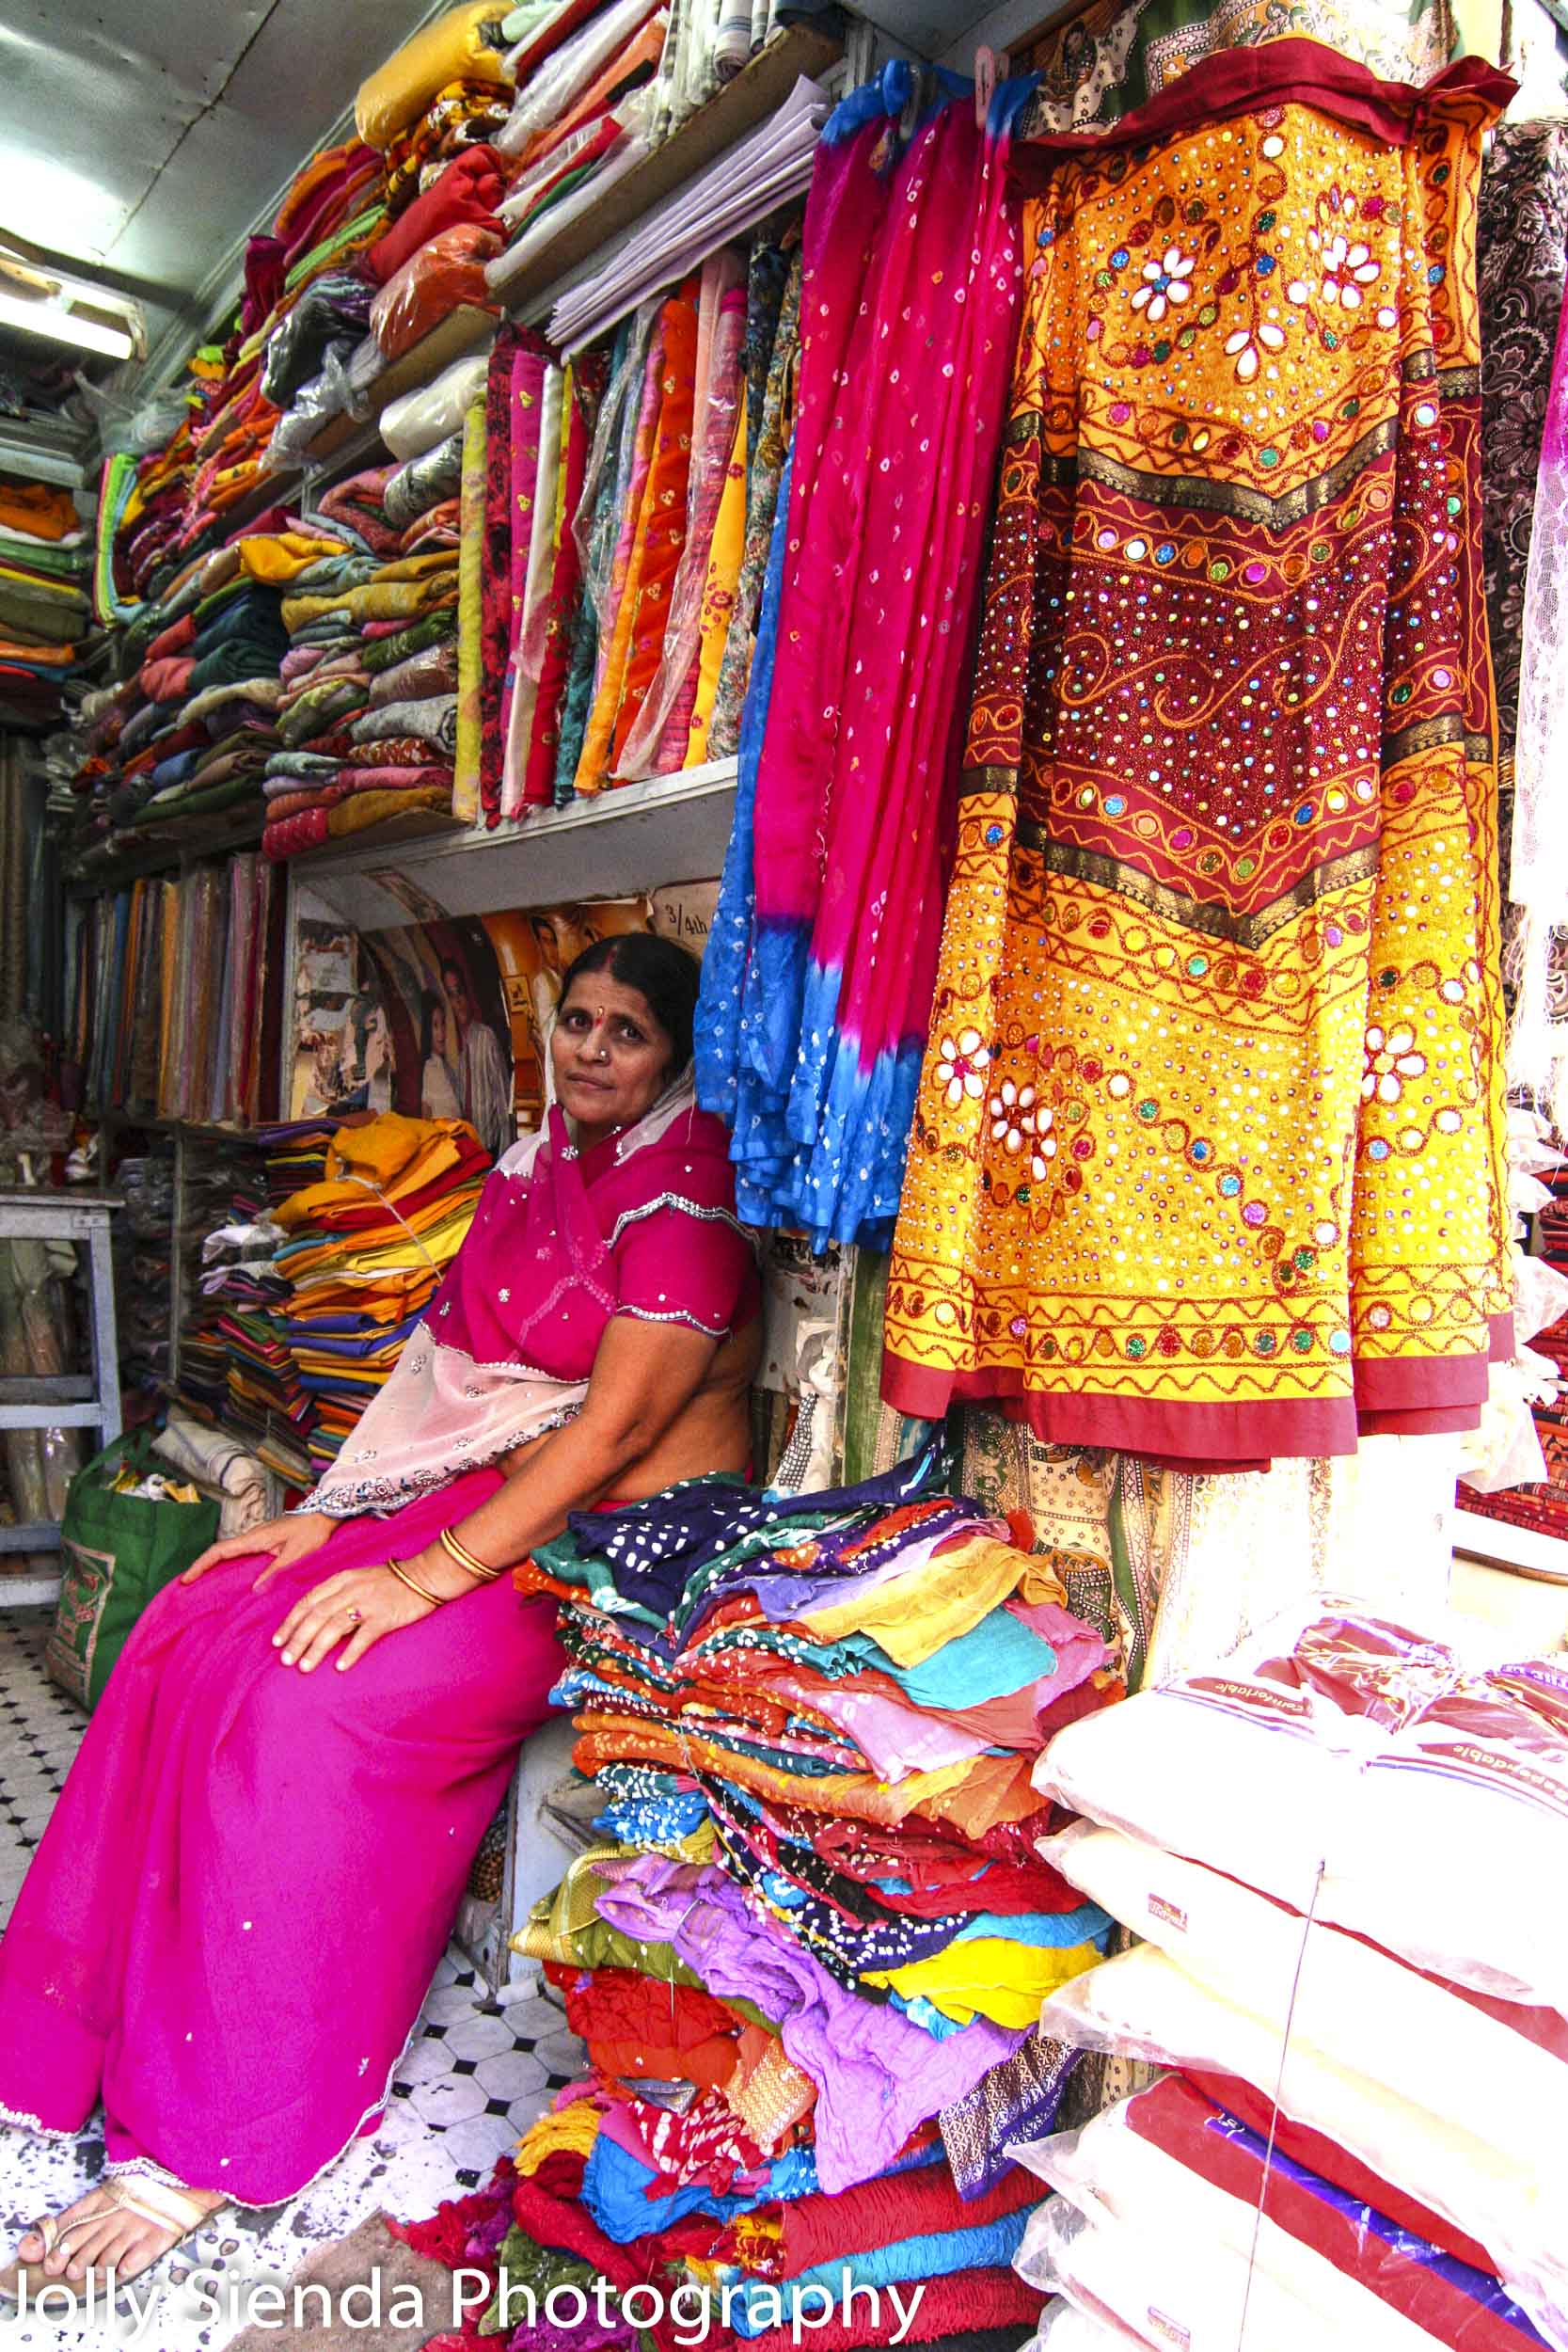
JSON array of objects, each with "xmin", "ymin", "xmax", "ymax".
[{"xmin": 1041, "ymin": 1823, "xmax": 1568, "ymax": 2183}]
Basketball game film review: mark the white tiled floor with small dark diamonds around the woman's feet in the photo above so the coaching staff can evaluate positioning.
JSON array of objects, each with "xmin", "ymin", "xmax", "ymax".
[{"xmin": 0, "ymin": 1609, "xmax": 580, "ymax": 2352}]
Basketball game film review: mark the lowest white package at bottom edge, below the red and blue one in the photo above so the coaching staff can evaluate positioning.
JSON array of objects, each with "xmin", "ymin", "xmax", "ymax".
[{"xmin": 1013, "ymin": 2106, "xmax": 1530, "ymax": 2352}]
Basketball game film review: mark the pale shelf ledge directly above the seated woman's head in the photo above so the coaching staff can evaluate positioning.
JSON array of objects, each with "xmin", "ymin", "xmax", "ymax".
[{"xmin": 292, "ymin": 760, "xmax": 736, "ymax": 931}]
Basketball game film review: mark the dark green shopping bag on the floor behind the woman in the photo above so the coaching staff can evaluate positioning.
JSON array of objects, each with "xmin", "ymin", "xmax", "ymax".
[{"xmin": 44, "ymin": 1430, "xmax": 218, "ymax": 1710}]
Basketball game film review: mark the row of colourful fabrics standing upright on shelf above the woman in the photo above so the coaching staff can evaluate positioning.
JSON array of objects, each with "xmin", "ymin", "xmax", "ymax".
[{"xmin": 477, "ymin": 233, "xmax": 800, "ymax": 826}]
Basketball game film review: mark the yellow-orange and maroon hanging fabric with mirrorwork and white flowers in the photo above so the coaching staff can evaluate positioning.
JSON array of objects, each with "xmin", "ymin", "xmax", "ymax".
[{"xmin": 884, "ymin": 40, "xmax": 1510, "ymax": 1466}]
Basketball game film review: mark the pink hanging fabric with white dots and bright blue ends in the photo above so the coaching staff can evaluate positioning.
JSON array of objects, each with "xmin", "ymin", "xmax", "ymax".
[{"xmin": 698, "ymin": 66, "xmax": 1032, "ymax": 1245}]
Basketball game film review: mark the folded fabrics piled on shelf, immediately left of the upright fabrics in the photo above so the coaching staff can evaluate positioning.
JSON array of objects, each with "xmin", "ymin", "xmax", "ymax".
[{"xmin": 263, "ymin": 463, "xmax": 461, "ymax": 859}]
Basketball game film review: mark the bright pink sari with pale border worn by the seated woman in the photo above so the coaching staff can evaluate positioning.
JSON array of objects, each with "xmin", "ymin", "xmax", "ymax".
[{"xmin": 0, "ymin": 1087, "xmax": 757, "ymax": 2204}]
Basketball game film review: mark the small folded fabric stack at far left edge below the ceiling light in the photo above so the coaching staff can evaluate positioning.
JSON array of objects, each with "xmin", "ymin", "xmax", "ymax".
[{"xmin": 0, "ymin": 475, "xmax": 91, "ymax": 729}]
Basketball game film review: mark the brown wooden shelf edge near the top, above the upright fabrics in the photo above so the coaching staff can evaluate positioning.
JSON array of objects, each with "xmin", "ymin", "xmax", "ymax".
[{"xmin": 496, "ymin": 24, "xmax": 844, "ymax": 320}]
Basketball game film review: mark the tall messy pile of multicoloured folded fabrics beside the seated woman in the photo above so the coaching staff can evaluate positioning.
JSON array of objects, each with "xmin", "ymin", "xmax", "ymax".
[{"xmin": 399, "ymin": 1447, "xmax": 1119, "ymax": 2347}]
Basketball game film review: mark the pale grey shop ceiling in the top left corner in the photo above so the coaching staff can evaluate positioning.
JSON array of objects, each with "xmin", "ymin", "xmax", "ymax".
[{"xmin": 0, "ymin": 0, "xmax": 435, "ymax": 433}]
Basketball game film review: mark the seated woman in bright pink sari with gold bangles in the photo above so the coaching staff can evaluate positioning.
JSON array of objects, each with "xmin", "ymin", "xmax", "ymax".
[{"xmin": 0, "ymin": 936, "xmax": 759, "ymax": 2294}]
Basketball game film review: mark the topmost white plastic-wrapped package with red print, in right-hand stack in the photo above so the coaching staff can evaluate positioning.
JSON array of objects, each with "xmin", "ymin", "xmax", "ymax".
[{"xmin": 1035, "ymin": 1599, "xmax": 1568, "ymax": 2013}]
